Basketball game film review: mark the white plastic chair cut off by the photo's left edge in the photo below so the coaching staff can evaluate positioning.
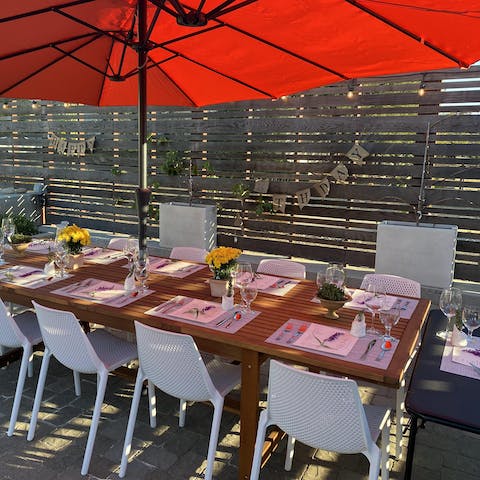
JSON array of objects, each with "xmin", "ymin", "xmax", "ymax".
[{"xmin": 0, "ymin": 300, "xmax": 42, "ymax": 437}]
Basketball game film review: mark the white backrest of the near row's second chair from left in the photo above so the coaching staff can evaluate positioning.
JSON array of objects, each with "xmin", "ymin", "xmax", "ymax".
[{"xmin": 32, "ymin": 301, "xmax": 104, "ymax": 373}]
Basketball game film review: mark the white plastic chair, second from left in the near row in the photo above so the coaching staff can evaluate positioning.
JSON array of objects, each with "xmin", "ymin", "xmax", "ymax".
[{"xmin": 27, "ymin": 302, "xmax": 137, "ymax": 475}]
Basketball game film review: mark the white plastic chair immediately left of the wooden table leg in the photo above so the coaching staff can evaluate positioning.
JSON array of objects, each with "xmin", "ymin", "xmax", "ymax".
[{"xmin": 119, "ymin": 322, "xmax": 241, "ymax": 480}]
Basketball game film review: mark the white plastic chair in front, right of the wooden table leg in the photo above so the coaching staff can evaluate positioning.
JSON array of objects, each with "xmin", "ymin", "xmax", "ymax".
[{"xmin": 250, "ymin": 360, "xmax": 390, "ymax": 480}]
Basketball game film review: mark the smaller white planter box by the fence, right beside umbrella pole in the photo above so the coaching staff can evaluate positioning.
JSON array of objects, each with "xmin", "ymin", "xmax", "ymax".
[{"xmin": 160, "ymin": 202, "xmax": 217, "ymax": 250}]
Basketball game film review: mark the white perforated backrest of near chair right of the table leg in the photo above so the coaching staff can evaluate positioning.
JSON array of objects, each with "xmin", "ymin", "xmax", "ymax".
[{"xmin": 267, "ymin": 360, "xmax": 372, "ymax": 453}]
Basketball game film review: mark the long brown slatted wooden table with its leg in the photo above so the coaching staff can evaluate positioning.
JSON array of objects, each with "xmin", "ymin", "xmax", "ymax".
[{"xmin": 0, "ymin": 254, "xmax": 430, "ymax": 480}]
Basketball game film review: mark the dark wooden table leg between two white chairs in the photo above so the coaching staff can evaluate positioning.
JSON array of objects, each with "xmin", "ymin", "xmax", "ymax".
[{"xmin": 238, "ymin": 350, "xmax": 260, "ymax": 480}]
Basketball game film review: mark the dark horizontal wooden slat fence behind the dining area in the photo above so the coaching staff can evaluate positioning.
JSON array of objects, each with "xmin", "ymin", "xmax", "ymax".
[{"xmin": 0, "ymin": 67, "xmax": 480, "ymax": 282}]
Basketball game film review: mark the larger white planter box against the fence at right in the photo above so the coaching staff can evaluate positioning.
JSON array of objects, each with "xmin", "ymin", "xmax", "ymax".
[{"xmin": 375, "ymin": 221, "xmax": 458, "ymax": 288}]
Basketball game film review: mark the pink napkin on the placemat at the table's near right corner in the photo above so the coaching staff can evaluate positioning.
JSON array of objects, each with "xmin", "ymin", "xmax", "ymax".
[{"xmin": 294, "ymin": 323, "xmax": 358, "ymax": 357}]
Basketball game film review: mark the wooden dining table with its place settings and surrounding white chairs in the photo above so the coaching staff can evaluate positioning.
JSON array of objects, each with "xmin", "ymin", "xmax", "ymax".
[{"xmin": 0, "ymin": 218, "xmax": 480, "ymax": 479}]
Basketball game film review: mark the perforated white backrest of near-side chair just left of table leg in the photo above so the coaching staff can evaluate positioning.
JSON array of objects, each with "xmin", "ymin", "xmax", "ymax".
[{"xmin": 135, "ymin": 322, "xmax": 217, "ymax": 401}]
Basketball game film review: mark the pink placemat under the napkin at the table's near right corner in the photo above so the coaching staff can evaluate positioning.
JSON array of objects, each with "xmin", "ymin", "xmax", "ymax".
[{"xmin": 265, "ymin": 319, "xmax": 398, "ymax": 370}]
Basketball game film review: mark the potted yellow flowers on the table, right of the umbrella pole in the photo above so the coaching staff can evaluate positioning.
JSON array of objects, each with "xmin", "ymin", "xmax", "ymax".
[{"xmin": 205, "ymin": 247, "xmax": 242, "ymax": 297}]
